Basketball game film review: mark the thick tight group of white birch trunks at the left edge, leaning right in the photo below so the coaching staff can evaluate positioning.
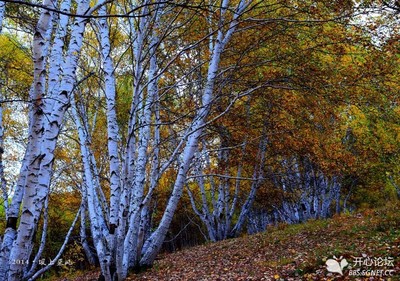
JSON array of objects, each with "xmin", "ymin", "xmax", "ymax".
[{"xmin": 0, "ymin": 0, "xmax": 108, "ymax": 280}]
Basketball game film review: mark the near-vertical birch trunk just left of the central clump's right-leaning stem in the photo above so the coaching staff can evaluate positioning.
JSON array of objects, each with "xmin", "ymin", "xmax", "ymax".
[{"xmin": 117, "ymin": 6, "xmax": 158, "ymax": 279}]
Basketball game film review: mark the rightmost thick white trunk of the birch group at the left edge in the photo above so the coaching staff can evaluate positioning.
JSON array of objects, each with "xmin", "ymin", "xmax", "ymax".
[{"xmin": 8, "ymin": 0, "xmax": 89, "ymax": 280}]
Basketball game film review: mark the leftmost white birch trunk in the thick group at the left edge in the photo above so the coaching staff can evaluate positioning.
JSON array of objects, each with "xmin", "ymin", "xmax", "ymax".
[{"xmin": 0, "ymin": 1, "xmax": 52, "ymax": 280}]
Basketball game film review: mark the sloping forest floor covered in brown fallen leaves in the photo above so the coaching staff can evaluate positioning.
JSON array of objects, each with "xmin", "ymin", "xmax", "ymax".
[{"xmin": 58, "ymin": 201, "xmax": 400, "ymax": 281}]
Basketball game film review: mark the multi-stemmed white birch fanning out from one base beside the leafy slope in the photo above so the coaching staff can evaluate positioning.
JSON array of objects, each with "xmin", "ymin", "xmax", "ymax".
[{"xmin": 65, "ymin": 1, "xmax": 253, "ymax": 280}]
